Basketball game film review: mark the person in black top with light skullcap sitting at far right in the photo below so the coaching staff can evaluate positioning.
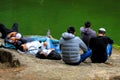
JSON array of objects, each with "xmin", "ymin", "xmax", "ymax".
[{"xmin": 89, "ymin": 28, "xmax": 113, "ymax": 63}]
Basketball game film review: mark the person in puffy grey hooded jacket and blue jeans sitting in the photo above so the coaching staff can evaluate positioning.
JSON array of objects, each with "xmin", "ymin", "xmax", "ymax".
[{"xmin": 60, "ymin": 26, "xmax": 91, "ymax": 65}]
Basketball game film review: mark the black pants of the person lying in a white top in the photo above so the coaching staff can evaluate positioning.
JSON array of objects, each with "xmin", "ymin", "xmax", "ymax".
[{"xmin": 36, "ymin": 50, "xmax": 61, "ymax": 60}]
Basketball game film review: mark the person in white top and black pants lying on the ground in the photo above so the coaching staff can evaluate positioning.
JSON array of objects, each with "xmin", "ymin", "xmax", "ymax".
[{"xmin": 18, "ymin": 41, "xmax": 61, "ymax": 60}]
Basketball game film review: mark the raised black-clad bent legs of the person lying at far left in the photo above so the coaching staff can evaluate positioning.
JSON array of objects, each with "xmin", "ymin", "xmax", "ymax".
[{"xmin": 0, "ymin": 23, "xmax": 18, "ymax": 39}]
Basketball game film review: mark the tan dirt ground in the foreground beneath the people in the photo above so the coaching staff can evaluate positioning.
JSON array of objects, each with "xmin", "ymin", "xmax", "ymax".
[{"xmin": 0, "ymin": 49, "xmax": 120, "ymax": 80}]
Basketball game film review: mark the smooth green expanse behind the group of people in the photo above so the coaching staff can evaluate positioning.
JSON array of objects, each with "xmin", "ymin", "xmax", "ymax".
[{"xmin": 0, "ymin": 0, "xmax": 120, "ymax": 45}]
